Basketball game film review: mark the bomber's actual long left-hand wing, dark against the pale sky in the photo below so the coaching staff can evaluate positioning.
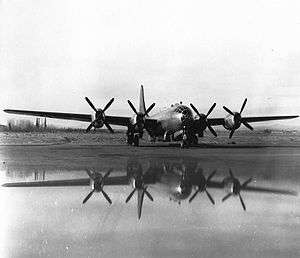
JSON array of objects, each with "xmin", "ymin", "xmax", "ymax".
[{"xmin": 4, "ymin": 109, "xmax": 134, "ymax": 126}]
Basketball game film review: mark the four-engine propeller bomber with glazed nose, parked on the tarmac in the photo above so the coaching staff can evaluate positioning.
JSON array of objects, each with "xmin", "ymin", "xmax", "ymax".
[{"xmin": 4, "ymin": 86, "xmax": 298, "ymax": 147}]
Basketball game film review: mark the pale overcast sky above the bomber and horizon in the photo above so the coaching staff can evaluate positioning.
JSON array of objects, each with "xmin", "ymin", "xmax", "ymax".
[{"xmin": 0, "ymin": 0, "xmax": 300, "ymax": 126}]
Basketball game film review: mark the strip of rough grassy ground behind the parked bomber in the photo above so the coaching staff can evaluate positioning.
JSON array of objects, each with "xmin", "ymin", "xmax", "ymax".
[{"xmin": 0, "ymin": 129, "xmax": 300, "ymax": 146}]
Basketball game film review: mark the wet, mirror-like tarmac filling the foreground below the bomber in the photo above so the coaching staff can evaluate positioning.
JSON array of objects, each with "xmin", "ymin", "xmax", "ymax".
[{"xmin": 0, "ymin": 145, "xmax": 300, "ymax": 257}]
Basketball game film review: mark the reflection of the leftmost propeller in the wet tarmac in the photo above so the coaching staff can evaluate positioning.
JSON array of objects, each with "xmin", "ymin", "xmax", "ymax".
[{"xmin": 82, "ymin": 169, "xmax": 112, "ymax": 204}]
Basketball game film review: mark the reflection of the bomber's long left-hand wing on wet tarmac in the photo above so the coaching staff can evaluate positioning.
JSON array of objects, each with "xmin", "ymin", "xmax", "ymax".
[{"xmin": 2, "ymin": 176, "xmax": 129, "ymax": 187}]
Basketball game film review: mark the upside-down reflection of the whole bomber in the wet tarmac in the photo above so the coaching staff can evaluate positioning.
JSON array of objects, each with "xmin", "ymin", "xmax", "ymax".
[{"xmin": 3, "ymin": 159, "xmax": 297, "ymax": 219}]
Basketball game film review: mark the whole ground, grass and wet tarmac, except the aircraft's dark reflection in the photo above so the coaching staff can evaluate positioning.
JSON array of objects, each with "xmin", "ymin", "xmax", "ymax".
[{"xmin": 0, "ymin": 131, "xmax": 300, "ymax": 257}]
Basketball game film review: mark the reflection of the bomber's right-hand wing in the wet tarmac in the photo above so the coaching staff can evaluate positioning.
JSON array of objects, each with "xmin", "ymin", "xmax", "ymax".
[{"xmin": 207, "ymin": 181, "xmax": 298, "ymax": 196}]
